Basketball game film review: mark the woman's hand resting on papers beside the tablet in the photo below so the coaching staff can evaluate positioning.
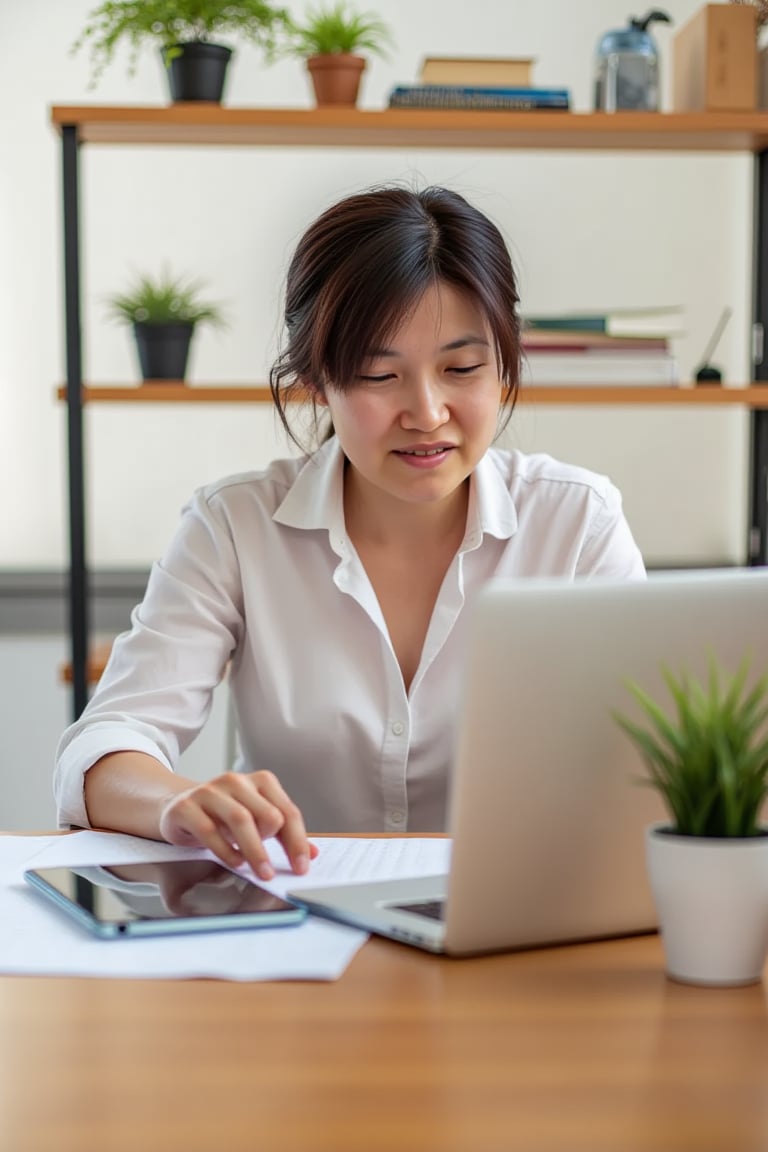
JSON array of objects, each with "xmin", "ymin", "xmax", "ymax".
[{"xmin": 160, "ymin": 772, "xmax": 318, "ymax": 880}]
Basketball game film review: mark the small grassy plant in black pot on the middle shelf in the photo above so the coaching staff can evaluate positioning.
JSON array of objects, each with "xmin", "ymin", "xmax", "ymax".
[{"xmin": 107, "ymin": 271, "xmax": 225, "ymax": 382}]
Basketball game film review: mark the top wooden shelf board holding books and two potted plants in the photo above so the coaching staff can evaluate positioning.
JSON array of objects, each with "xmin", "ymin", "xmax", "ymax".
[{"xmin": 51, "ymin": 103, "xmax": 768, "ymax": 152}]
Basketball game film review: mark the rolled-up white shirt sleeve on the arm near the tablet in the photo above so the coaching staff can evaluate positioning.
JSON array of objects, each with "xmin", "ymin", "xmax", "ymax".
[{"xmin": 54, "ymin": 492, "xmax": 243, "ymax": 827}]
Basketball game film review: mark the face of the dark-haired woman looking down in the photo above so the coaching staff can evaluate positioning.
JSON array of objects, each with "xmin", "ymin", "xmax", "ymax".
[{"xmin": 324, "ymin": 283, "xmax": 502, "ymax": 516}]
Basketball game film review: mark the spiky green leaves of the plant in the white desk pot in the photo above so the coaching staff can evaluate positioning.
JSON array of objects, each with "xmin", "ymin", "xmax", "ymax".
[{"xmin": 613, "ymin": 659, "xmax": 768, "ymax": 838}]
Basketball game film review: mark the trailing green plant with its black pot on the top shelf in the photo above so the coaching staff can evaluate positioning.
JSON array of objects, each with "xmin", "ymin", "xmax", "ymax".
[{"xmin": 73, "ymin": 0, "xmax": 290, "ymax": 103}]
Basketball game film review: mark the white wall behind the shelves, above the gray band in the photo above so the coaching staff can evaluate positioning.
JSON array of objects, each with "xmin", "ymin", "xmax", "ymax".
[{"xmin": 0, "ymin": 0, "xmax": 752, "ymax": 567}]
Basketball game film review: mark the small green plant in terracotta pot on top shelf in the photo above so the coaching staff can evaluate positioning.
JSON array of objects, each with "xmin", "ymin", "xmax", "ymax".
[{"xmin": 288, "ymin": 0, "xmax": 394, "ymax": 107}]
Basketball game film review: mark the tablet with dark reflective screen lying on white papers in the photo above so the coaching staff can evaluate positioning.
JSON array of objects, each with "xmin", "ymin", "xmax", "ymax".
[{"xmin": 24, "ymin": 859, "xmax": 306, "ymax": 939}]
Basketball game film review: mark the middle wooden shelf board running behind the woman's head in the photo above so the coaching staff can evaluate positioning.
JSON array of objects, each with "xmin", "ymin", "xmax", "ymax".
[{"xmin": 56, "ymin": 382, "xmax": 768, "ymax": 408}]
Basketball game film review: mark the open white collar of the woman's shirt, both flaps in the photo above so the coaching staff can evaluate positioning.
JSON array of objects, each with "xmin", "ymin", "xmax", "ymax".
[{"xmin": 273, "ymin": 437, "xmax": 517, "ymax": 550}]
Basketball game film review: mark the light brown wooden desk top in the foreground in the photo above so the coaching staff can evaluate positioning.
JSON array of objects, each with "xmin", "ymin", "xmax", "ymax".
[{"xmin": 0, "ymin": 937, "xmax": 768, "ymax": 1152}]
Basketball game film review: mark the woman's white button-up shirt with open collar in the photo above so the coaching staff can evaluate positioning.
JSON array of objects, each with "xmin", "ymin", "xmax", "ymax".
[{"xmin": 55, "ymin": 439, "xmax": 645, "ymax": 833}]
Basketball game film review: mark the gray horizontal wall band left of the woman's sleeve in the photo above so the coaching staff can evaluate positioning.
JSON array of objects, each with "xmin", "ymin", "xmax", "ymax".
[{"xmin": 0, "ymin": 569, "xmax": 149, "ymax": 636}]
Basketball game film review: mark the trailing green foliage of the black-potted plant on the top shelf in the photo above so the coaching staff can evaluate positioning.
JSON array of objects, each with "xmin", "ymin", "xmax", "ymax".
[{"xmin": 71, "ymin": 0, "xmax": 291, "ymax": 88}]
